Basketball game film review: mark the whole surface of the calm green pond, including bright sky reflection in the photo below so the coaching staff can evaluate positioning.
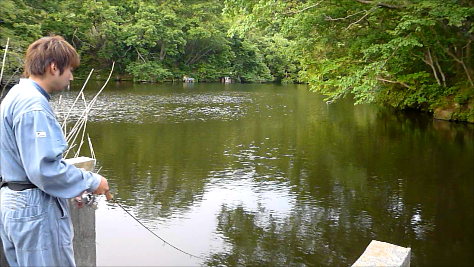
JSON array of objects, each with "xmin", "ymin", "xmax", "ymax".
[{"xmin": 54, "ymin": 83, "xmax": 474, "ymax": 266}]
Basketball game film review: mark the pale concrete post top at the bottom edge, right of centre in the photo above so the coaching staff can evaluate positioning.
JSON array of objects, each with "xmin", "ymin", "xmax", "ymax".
[{"xmin": 352, "ymin": 240, "xmax": 411, "ymax": 267}]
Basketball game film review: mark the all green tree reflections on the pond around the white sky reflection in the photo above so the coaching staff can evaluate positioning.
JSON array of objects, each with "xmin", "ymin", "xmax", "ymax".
[{"xmin": 76, "ymin": 86, "xmax": 474, "ymax": 266}]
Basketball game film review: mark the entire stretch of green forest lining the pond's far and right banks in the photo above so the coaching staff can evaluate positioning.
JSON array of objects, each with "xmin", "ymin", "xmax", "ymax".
[{"xmin": 0, "ymin": 0, "xmax": 474, "ymax": 122}]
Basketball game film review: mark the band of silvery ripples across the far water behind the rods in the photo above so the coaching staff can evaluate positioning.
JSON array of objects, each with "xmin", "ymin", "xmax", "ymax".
[{"xmin": 51, "ymin": 92, "xmax": 252, "ymax": 123}]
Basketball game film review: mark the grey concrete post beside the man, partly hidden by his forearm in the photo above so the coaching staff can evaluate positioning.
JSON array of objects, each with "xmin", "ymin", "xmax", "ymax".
[{"xmin": 0, "ymin": 157, "xmax": 97, "ymax": 267}]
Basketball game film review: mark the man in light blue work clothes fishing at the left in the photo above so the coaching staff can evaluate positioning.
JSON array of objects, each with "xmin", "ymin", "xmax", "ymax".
[{"xmin": 0, "ymin": 36, "xmax": 109, "ymax": 267}]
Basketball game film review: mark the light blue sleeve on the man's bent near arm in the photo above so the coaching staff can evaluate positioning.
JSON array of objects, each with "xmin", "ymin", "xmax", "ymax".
[{"xmin": 14, "ymin": 110, "xmax": 101, "ymax": 198}]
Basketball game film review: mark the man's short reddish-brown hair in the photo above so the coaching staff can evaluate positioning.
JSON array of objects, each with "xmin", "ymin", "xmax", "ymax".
[{"xmin": 23, "ymin": 35, "xmax": 79, "ymax": 78}]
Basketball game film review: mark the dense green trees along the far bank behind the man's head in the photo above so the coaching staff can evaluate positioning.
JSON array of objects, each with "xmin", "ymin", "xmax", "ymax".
[{"xmin": 0, "ymin": 0, "xmax": 286, "ymax": 82}]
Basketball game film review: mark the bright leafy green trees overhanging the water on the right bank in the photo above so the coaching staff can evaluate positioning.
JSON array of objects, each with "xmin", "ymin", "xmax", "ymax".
[{"xmin": 226, "ymin": 0, "xmax": 474, "ymax": 120}]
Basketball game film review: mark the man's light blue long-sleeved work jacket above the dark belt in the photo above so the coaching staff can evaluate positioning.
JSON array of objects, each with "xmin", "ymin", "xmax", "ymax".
[{"xmin": 0, "ymin": 79, "xmax": 101, "ymax": 198}]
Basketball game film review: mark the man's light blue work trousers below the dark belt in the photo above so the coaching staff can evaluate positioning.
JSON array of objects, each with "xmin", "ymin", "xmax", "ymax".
[{"xmin": 0, "ymin": 187, "xmax": 75, "ymax": 267}]
